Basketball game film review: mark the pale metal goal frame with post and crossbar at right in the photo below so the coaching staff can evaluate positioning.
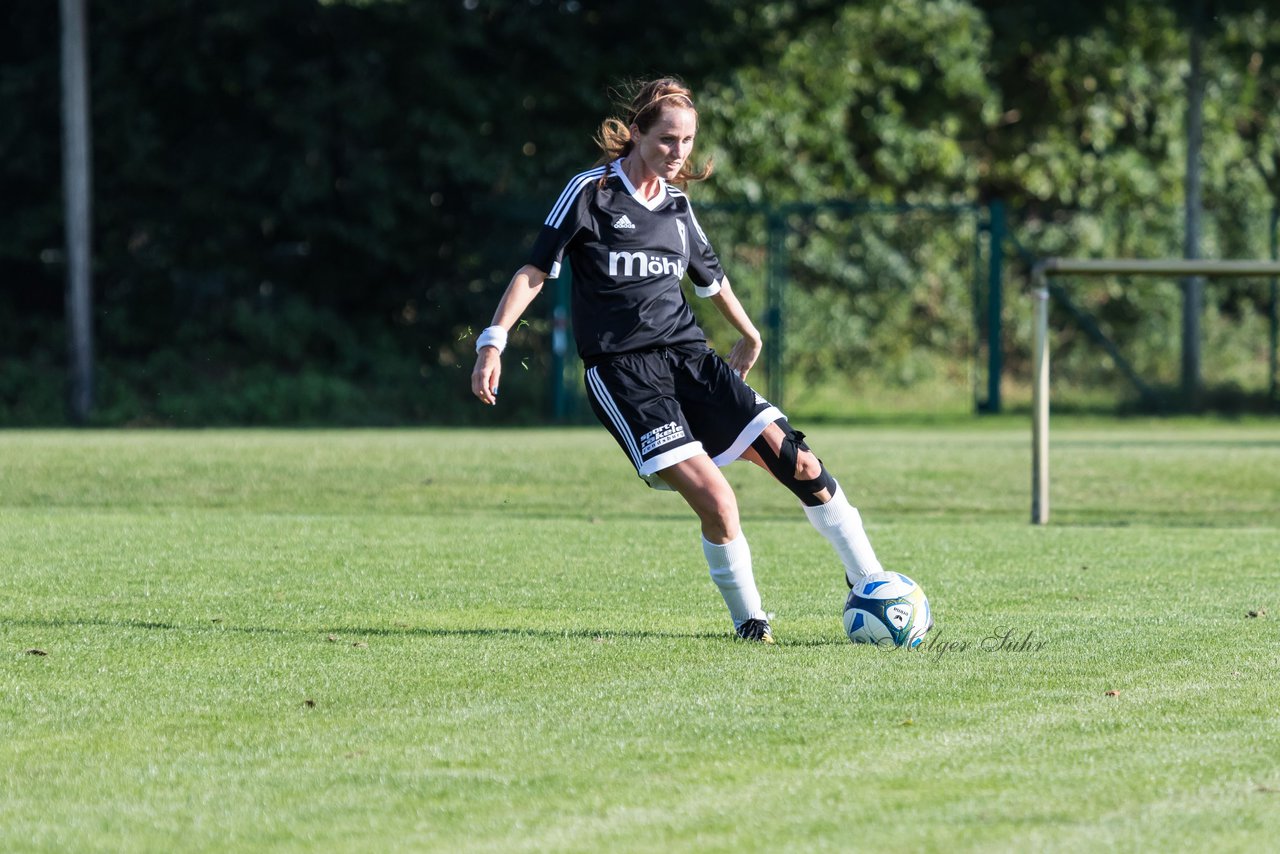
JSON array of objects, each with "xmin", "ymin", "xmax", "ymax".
[{"xmin": 1032, "ymin": 257, "xmax": 1280, "ymax": 525}]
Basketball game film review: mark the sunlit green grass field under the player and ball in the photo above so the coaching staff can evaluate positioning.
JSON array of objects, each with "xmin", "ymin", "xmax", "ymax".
[{"xmin": 0, "ymin": 419, "xmax": 1280, "ymax": 851}]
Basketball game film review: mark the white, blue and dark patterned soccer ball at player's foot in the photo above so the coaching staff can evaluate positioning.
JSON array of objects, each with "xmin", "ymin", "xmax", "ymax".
[{"xmin": 845, "ymin": 572, "xmax": 933, "ymax": 649}]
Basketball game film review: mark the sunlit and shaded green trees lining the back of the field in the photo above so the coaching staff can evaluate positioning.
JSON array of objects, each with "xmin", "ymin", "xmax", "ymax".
[{"xmin": 0, "ymin": 0, "xmax": 1280, "ymax": 425}]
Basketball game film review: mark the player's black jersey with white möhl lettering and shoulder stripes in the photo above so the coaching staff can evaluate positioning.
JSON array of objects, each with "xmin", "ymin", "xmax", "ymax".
[{"xmin": 529, "ymin": 160, "xmax": 724, "ymax": 365}]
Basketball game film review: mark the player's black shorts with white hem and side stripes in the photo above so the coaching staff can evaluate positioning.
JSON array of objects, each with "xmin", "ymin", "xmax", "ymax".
[{"xmin": 586, "ymin": 344, "xmax": 782, "ymax": 489}]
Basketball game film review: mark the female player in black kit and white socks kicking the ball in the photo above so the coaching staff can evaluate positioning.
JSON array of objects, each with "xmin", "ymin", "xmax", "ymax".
[{"xmin": 471, "ymin": 78, "xmax": 881, "ymax": 644}]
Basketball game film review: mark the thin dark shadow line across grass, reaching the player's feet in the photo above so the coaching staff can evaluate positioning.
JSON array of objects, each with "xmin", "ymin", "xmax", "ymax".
[{"xmin": 0, "ymin": 617, "xmax": 849, "ymax": 647}]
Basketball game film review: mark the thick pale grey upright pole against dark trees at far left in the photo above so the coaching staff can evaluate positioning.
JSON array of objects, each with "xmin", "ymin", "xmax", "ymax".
[{"xmin": 61, "ymin": 0, "xmax": 93, "ymax": 424}]
